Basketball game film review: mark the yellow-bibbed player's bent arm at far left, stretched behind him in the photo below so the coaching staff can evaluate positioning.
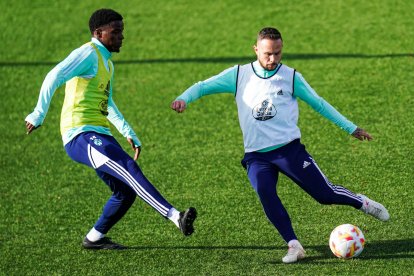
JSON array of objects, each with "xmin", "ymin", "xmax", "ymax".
[{"xmin": 25, "ymin": 47, "xmax": 97, "ymax": 134}]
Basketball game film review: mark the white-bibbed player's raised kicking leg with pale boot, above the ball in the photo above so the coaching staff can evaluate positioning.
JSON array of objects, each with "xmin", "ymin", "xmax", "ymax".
[{"xmin": 277, "ymin": 142, "xmax": 389, "ymax": 220}]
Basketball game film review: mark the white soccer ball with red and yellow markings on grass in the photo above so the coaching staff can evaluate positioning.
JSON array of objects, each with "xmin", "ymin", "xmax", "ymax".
[{"xmin": 329, "ymin": 224, "xmax": 365, "ymax": 259}]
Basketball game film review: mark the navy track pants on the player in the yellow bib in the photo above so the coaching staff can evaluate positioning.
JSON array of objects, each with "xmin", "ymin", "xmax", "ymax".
[{"xmin": 65, "ymin": 132, "xmax": 172, "ymax": 234}]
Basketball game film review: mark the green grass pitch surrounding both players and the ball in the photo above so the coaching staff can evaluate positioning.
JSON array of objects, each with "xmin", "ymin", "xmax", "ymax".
[{"xmin": 0, "ymin": 0, "xmax": 414, "ymax": 275}]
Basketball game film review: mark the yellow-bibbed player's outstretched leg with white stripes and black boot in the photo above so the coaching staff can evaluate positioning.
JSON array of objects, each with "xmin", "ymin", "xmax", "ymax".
[{"xmin": 65, "ymin": 132, "xmax": 197, "ymax": 245}]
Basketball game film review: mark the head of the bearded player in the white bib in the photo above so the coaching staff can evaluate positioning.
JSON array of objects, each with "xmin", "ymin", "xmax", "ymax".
[{"xmin": 253, "ymin": 27, "xmax": 283, "ymax": 70}]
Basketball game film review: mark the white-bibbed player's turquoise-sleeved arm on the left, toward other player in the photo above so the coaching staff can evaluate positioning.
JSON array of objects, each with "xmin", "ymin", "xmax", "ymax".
[{"xmin": 171, "ymin": 65, "xmax": 238, "ymax": 113}]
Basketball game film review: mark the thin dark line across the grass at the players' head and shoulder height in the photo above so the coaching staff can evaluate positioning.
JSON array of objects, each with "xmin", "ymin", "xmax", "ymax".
[{"xmin": 0, "ymin": 53, "xmax": 414, "ymax": 67}]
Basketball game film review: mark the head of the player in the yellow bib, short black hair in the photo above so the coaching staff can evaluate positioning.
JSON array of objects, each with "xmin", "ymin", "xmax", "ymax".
[{"xmin": 89, "ymin": 9, "xmax": 124, "ymax": 52}]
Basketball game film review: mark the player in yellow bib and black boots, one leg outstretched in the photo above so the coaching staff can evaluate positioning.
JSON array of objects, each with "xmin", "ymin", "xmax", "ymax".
[{"xmin": 25, "ymin": 9, "xmax": 197, "ymax": 249}]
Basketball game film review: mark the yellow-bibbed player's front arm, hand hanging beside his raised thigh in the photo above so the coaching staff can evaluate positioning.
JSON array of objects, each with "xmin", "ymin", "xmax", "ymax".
[{"xmin": 107, "ymin": 76, "xmax": 141, "ymax": 160}]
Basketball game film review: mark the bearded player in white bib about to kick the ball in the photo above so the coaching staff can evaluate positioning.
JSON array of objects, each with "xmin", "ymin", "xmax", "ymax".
[{"xmin": 171, "ymin": 27, "xmax": 389, "ymax": 263}]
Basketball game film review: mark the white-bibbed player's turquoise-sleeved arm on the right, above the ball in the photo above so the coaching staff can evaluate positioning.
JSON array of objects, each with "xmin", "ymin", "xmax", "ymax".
[{"xmin": 294, "ymin": 72, "xmax": 372, "ymax": 140}]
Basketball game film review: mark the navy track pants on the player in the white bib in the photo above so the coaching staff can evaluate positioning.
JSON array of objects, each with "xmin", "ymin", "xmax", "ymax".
[{"xmin": 242, "ymin": 139, "xmax": 362, "ymax": 242}]
